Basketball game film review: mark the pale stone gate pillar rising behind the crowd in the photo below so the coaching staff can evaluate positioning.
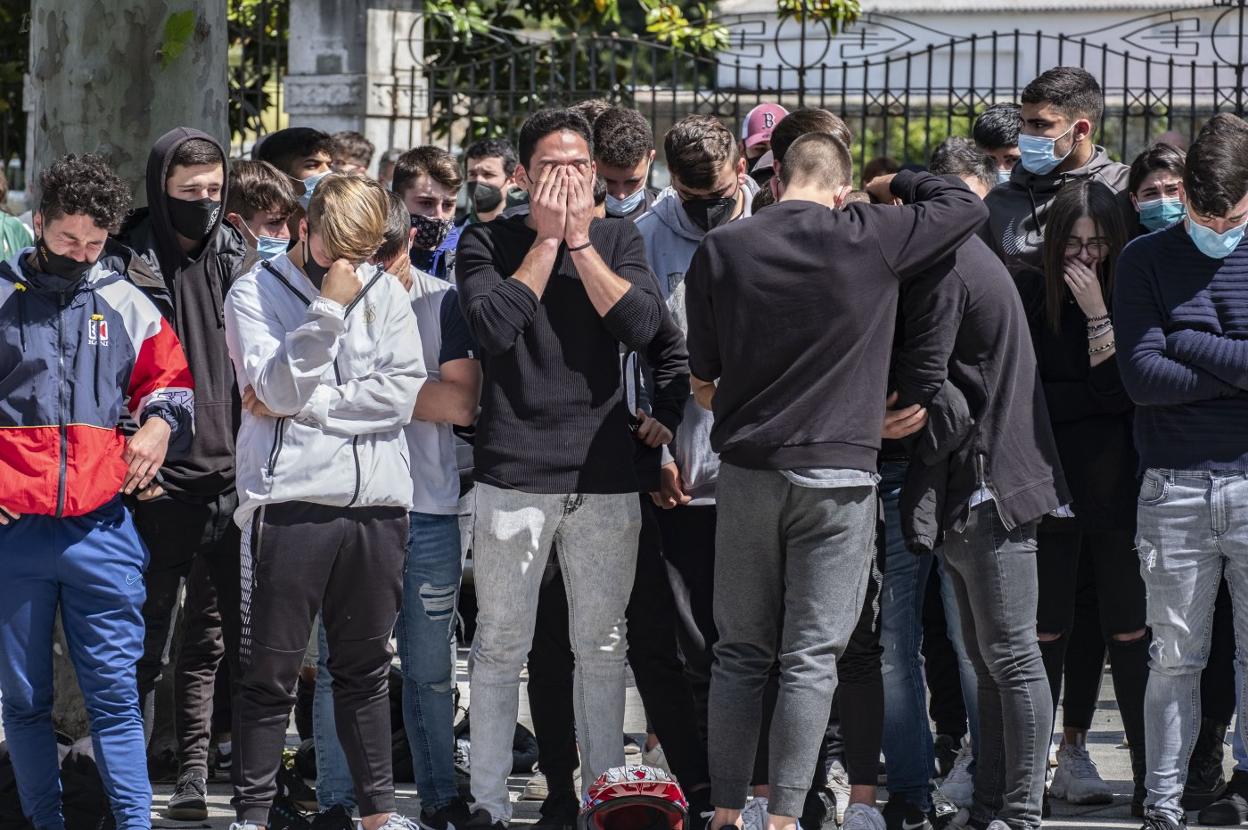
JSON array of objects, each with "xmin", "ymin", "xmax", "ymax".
[{"xmin": 285, "ymin": 0, "xmax": 428, "ymax": 173}]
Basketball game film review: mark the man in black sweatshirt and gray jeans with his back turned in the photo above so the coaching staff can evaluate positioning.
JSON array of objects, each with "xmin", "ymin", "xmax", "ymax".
[{"xmin": 686, "ymin": 134, "xmax": 985, "ymax": 830}]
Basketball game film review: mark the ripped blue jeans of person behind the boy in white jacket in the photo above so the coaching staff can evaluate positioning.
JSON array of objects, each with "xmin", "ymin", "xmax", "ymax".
[{"xmin": 313, "ymin": 513, "xmax": 463, "ymax": 811}]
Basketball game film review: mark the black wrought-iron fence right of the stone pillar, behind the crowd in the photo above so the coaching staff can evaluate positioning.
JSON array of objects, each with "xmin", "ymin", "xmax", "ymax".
[{"xmin": 396, "ymin": 0, "xmax": 1248, "ymax": 164}]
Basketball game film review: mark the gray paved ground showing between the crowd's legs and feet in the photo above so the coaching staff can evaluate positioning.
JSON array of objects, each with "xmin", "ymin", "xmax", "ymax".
[{"xmin": 139, "ymin": 660, "xmax": 1231, "ymax": 830}]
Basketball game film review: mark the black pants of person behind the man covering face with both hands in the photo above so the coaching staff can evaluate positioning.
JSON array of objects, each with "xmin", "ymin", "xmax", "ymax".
[{"xmin": 528, "ymin": 496, "xmax": 710, "ymax": 793}]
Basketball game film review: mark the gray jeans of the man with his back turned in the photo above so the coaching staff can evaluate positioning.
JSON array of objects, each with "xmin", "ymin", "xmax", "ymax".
[{"xmin": 708, "ymin": 463, "xmax": 879, "ymax": 816}]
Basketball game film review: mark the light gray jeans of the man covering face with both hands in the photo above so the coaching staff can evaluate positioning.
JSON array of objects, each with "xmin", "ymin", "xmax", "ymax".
[{"xmin": 469, "ymin": 483, "xmax": 641, "ymax": 823}]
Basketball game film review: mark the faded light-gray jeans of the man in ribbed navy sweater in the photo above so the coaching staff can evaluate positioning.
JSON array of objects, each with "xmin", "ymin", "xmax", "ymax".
[{"xmin": 1136, "ymin": 469, "xmax": 1248, "ymax": 819}]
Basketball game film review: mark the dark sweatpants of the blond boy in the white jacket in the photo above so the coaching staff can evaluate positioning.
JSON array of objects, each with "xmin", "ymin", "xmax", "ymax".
[{"xmin": 233, "ymin": 502, "xmax": 408, "ymax": 825}]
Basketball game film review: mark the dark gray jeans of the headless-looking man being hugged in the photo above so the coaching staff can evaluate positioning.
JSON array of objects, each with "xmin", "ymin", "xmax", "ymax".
[{"xmin": 941, "ymin": 500, "xmax": 1053, "ymax": 830}]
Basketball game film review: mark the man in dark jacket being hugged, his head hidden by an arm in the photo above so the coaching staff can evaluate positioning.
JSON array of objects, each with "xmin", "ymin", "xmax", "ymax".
[{"xmin": 894, "ymin": 199, "xmax": 1071, "ymax": 830}]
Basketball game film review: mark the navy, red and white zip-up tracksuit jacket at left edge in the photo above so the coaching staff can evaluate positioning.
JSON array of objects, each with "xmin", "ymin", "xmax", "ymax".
[{"xmin": 0, "ymin": 248, "xmax": 193, "ymax": 517}]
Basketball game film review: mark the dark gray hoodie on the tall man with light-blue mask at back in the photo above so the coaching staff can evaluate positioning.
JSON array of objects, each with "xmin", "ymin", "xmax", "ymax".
[{"xmin": 983, "ymin": 146, "xmax": 1139, "ymax": 280}]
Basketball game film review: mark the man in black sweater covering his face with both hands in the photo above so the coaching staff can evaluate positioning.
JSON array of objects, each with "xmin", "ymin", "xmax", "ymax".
[{"xmin": 457, "ymin": 110, "xmax": 663, "ymax": 828}]
